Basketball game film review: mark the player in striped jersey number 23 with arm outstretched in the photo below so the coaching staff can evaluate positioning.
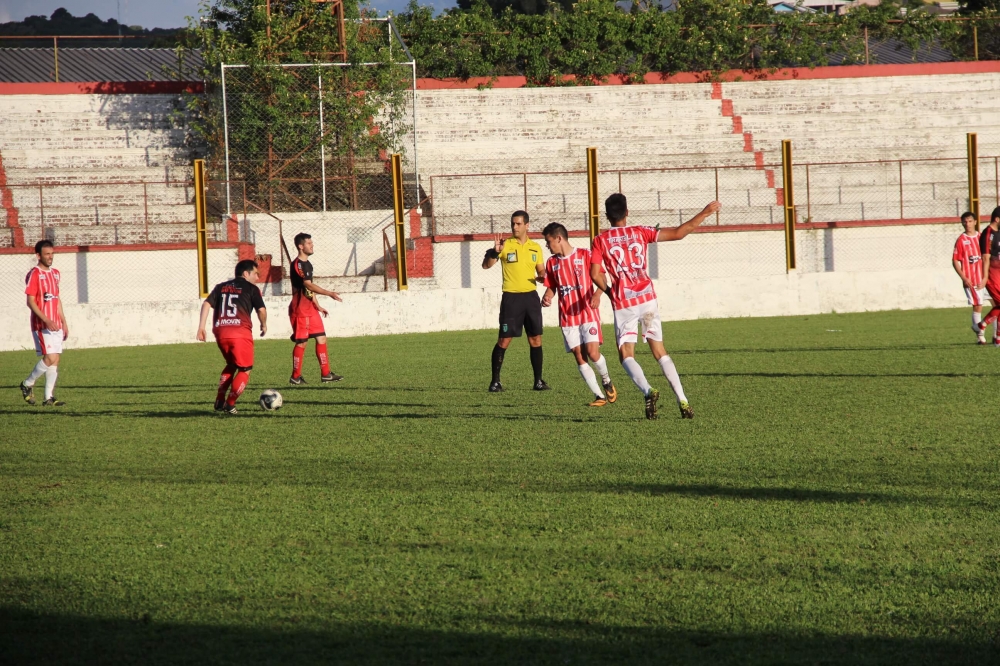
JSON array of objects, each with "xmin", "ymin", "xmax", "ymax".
[{"xmin": 590, "ymin": 194, "xmax": 721, "ymax": 419}]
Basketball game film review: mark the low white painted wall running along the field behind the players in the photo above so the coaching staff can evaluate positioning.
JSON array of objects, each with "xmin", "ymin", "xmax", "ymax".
[{"xmin": 0, "ymin": 225, "xmax": 965, "ymax": 350}]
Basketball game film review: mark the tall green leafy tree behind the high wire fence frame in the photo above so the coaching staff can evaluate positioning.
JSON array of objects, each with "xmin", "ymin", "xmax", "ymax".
[{"xmin": 191, "ymin": 0, "xmax": 411, "ymax": 210}]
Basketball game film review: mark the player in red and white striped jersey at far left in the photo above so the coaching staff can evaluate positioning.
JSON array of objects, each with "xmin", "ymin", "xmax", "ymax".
[{"xmin": 21, "ymin": 240, "xmax": 69, "ymax": 407}]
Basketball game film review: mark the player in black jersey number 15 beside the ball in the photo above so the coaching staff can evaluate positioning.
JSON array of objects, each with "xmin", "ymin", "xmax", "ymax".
[{"xmin": 198, "ymin": 259, "xmax": 267, "ymax": 414}]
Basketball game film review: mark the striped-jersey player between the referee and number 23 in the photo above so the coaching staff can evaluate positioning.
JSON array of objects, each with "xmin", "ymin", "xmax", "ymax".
[{"xmin": 542, "ymin": 222, "xmax": 618, "ymax": 407}]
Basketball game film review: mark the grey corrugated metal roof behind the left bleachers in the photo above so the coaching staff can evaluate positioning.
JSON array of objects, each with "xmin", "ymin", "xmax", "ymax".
[{"xmin": 0, "ymin": 48, "xmax": 204, "ymax": 83}]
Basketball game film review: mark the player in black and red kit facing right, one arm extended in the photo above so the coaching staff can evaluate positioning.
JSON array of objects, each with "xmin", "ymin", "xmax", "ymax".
[{"xmin": 288, "ymin": 234, "xmax": 343, "ymax": 386}]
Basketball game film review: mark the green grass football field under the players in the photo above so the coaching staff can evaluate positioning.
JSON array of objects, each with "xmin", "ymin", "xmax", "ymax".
[{"xmin": 0, "ymin": 309, "xmax": 1000, "ymax": 665}]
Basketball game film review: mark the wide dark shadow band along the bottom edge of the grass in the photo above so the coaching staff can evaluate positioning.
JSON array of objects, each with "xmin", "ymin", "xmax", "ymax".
[{"xmin": 0, "ymin": 602, "xmax": 997, "ymax": 666}]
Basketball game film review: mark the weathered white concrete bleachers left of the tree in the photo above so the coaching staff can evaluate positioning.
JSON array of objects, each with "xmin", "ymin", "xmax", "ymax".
[{"xmin": 0, "ymin": 94, "xmax": 194, "ymax": 247}]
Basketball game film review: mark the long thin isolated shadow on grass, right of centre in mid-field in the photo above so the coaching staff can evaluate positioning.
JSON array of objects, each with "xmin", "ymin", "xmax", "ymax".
[{"xmin": 591, "ymin": 483, "xmax": 913, "ymax": 504}]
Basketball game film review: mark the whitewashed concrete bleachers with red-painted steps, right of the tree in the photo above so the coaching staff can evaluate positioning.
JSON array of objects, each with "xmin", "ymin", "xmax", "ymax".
[{"xmin": 417, "ymin": 73, "xmax": 1000, "ymax": 234}]
